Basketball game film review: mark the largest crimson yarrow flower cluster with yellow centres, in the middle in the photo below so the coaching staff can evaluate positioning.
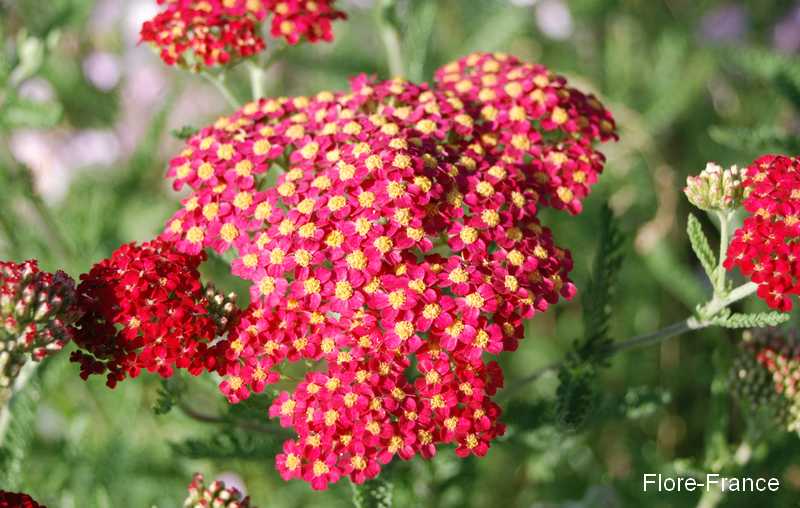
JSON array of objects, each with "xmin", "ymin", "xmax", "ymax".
[{"xmin": 163, "ymin": 53, "xmax": 615, "ymax": 488}]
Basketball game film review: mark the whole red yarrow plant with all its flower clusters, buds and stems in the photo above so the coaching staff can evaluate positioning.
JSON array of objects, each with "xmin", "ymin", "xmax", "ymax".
[{"xmin": 0, "ymin": 0, "xmax": 800, "ymax": 502}]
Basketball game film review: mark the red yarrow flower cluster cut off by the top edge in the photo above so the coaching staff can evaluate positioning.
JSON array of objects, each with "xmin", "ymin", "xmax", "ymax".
[{"xmin": 141, "ymin": 0, "xmax": 345, "ymax": 69}]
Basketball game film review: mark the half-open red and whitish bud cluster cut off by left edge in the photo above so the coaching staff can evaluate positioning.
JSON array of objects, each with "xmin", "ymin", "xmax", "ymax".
[{"xmin": 0, "ymin": 260, "xmax": 80, "ymax": 402}]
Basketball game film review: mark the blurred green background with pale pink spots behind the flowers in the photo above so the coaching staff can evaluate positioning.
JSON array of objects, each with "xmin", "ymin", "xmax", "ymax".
[{"xmin": 0, "ymin": 0, "xmax": 800, "ymax": 508}]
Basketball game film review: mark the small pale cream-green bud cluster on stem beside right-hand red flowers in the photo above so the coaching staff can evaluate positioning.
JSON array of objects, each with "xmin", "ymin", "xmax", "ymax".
[{"xmin": 684, "ymin": 162, "xmax": 746, "ymax": 212}]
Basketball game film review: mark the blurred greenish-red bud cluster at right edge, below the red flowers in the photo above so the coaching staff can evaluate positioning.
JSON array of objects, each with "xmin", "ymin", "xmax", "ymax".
[{"xmin": 731, "ymin": 329, "xmax": 800, "ymax": 432}]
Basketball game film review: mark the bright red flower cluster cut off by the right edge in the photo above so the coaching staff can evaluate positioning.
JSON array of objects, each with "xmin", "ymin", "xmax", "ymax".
[{"xmin": 725, "ymin": 155, "xmax": 800, "ymax": 312}]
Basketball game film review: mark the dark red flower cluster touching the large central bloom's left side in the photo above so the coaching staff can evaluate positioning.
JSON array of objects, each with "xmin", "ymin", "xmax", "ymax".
[{"xmin": 71, "ymin": 239, "xmax": 221, "ymax": 387}]
